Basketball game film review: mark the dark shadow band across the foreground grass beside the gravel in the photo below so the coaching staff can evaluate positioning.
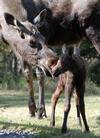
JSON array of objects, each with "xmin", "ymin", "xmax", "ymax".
[{"xmin": 0, "ymin": 121, "xmax": 100, "ymax": 138}]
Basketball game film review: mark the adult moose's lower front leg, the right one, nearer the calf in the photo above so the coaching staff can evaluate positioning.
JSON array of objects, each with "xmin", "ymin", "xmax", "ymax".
[{"xmin": 36, "ymin": 68, "xmax": 47, "ymax": 119}]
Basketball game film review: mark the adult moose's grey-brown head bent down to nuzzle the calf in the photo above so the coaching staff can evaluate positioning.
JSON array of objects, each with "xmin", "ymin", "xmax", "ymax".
[{"xmin": 0, "ymin": 11, "xmax": 57, "ymax": 76}]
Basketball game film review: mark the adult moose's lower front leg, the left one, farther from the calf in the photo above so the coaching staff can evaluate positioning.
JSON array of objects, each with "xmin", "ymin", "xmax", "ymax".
[{"xmin": 25, "ymin": 66, "xmax": 36, "ymax": 116}]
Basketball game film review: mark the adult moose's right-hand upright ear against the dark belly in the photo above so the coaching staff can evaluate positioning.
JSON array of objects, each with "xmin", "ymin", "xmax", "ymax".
[{"xmin": 33, "ymin": 9, "xmax": 47, "ymax": 27}]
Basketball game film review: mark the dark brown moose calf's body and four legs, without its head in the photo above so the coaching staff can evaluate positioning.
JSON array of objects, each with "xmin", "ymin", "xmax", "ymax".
[{"xmin": 51, "ymin": 55, "xmax": 89, "ymax": 133}]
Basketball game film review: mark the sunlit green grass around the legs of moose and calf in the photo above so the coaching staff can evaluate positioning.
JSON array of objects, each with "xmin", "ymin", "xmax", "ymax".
[{"xmin": 0, "ymin": 81, "xmax": 100, "ymax": 138}]
